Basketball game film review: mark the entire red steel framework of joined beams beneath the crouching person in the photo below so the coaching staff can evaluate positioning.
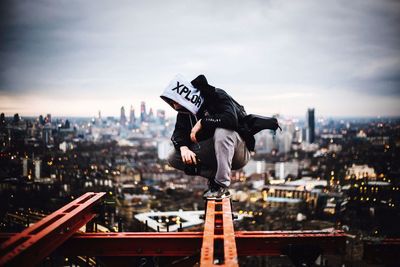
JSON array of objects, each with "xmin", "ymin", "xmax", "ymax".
[{"xmin": 0, "ymin": 192, "xmax": 354, "ymax": 267}]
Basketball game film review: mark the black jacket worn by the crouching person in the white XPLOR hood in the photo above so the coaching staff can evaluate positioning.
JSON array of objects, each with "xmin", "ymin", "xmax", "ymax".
[{"xmin": 171, "ymin": 75, "xmax": 279, "ymax": 151}]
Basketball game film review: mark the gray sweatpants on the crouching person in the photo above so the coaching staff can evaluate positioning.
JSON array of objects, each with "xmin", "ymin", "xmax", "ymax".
[{"xmin": 168, "ymin": 128, "xmax": 250, "ymax": 187}]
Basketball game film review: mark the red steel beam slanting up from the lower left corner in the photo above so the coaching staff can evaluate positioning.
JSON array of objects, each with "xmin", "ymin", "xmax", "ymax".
[{"xmin": 0, "ymin": 192, "xmax": 105, "ymax": 266}]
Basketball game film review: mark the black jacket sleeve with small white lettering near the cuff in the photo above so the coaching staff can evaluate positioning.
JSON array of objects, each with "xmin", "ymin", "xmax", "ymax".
[{"xmin": 201, "ymin": 89, "xmax": 238, "ymax": 130}]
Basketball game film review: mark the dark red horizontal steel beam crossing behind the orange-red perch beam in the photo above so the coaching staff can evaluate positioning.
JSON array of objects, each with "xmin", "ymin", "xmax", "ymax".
[{"xmin": 57, "ymin": 231, "xmax": 347, "ymax": 256}]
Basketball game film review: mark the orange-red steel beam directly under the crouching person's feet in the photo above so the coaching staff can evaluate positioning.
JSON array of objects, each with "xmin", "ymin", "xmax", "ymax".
[{"xmin": 200, "ymin": 198, "xmax": 239, "ymax": 267}]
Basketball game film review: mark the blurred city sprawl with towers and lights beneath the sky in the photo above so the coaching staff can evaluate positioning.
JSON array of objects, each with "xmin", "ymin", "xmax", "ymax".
[{"xmin": 0, "ymin": 102, "xmax": 400, "ymax": 266}]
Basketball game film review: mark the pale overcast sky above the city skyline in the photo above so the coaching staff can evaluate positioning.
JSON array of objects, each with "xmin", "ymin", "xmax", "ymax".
[{"xmin": 0, "ymin": 0, "xmax": 400, "ymax": 116}]
